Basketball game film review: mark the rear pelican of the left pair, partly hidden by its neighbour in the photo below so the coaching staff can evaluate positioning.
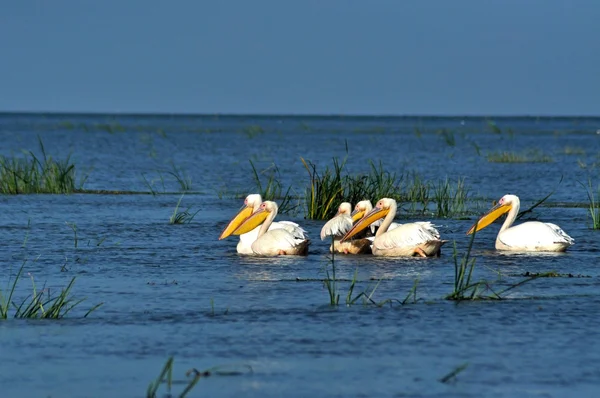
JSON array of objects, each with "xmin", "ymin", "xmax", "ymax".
[{"xmin": 219, "ymin": 194, "xmax": 308, "ymax": 254}]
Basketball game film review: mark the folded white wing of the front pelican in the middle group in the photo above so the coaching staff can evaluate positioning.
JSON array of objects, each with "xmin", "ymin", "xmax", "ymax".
[{"xmin": 373, "ymin": 222, "xmax": 440, "ymax": 250}]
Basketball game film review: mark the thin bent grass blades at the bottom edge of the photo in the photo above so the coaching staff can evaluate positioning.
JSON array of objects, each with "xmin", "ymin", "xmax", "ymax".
[{"xmin": 146, "ymin": 357, "xmax": 253, "ymax": 398}]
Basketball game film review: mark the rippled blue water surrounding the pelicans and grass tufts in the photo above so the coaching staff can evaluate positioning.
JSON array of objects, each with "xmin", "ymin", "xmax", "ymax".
[{"xmin": 0, "ymin": 114, "xmax": 600, "ymax": 397}]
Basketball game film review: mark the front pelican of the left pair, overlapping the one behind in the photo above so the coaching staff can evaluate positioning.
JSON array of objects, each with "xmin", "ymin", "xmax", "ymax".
[{"xmin": 234, "ymin": 201, "xmax": 310, "ymax": 256}]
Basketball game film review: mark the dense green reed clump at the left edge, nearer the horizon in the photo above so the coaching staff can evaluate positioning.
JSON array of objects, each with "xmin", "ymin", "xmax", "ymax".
[{"xmin": 0, "ymin": 137, "xmax": 87, "ymax": 194}]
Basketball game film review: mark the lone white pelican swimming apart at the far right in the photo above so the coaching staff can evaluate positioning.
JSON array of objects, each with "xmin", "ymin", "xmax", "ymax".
[{"xmin": 467, "ymin": 195, "xmax": 575, "ymax": 252}]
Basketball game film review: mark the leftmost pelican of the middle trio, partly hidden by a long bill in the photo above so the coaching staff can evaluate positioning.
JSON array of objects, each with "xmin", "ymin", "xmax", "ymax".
[{"xmin": 321, "ymin": 202, "xmax": 371, "ymax": 254}]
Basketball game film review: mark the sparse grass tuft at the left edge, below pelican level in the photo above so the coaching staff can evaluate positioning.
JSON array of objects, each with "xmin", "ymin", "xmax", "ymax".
[{"xmin": 0, "ymin": 260, "xmax": 104, "ymax": 319}]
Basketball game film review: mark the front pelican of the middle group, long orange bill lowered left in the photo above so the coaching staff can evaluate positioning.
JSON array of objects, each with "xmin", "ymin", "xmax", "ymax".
[{"xmin": 341, "ymin": 198, "xmax": 447, "ymax": 257}]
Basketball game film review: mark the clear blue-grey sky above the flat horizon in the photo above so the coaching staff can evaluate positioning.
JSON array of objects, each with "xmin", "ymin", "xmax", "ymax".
[{"xmin": 0, "ymin": 0, "xmax": 600, "ymax": 116}]
